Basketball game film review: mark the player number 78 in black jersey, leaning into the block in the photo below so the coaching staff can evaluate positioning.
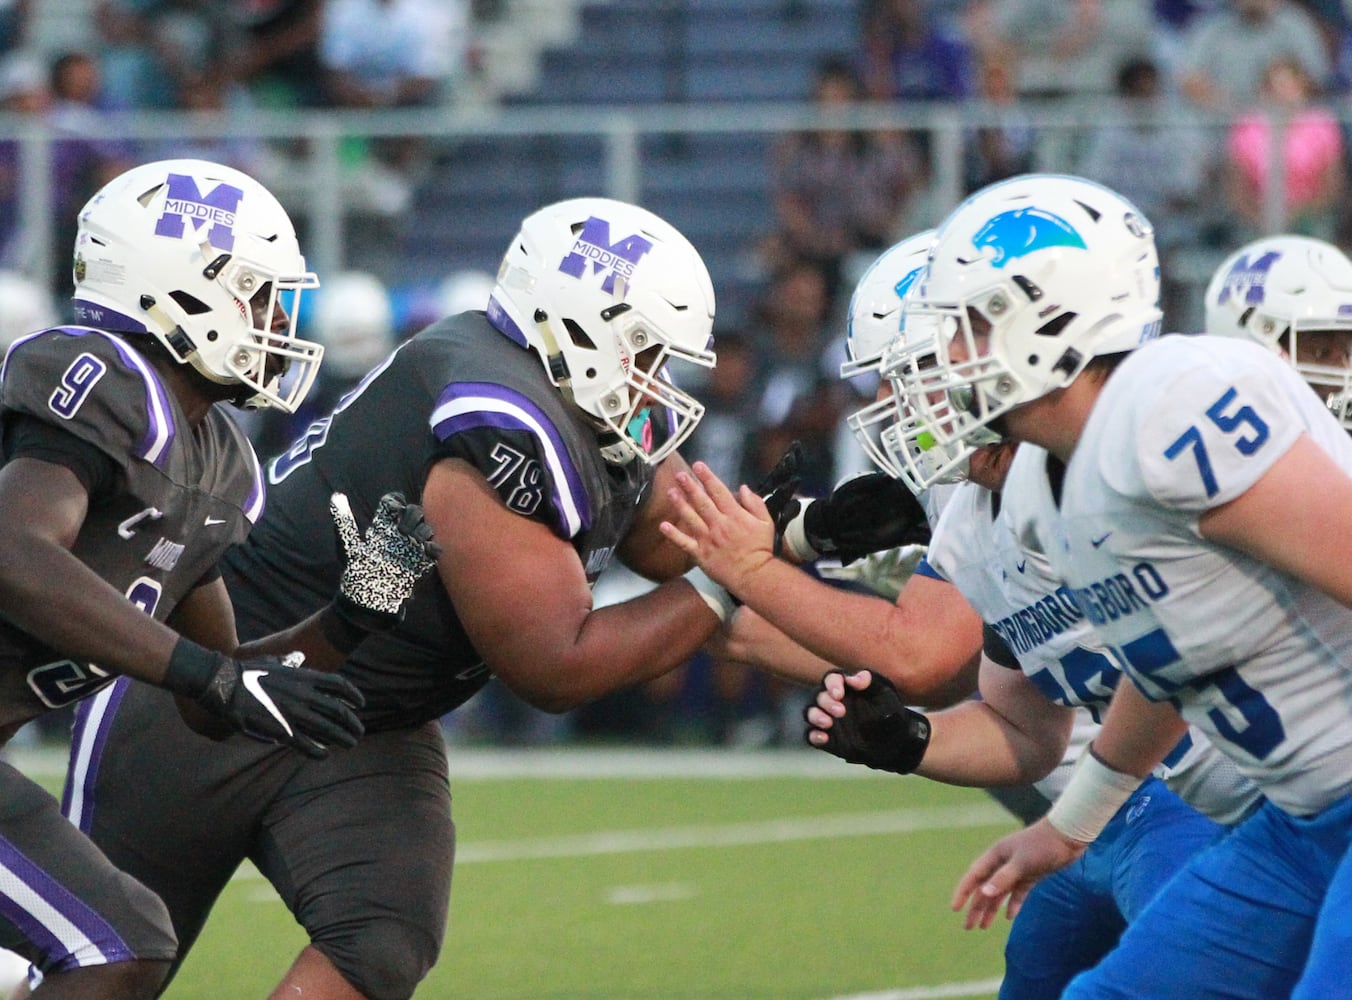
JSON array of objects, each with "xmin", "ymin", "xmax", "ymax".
[{"xmin": 60, "ymin": 197, "xmax": 731, "ymax": 1000}]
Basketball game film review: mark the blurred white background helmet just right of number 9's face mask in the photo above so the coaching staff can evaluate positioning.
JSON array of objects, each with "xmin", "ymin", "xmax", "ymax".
[{"xmin": 311, "ymin": 270, "xmax": 396, "ymax": 381}]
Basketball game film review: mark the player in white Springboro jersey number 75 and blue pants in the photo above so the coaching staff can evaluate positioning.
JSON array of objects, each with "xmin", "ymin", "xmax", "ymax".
[{"xmin": 876, "ymin": 176, "xmax": 1352, "ymax": 1000}]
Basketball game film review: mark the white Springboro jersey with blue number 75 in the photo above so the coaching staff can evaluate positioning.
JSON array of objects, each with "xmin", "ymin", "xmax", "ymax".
[{"xmin": 1007, "ymin": 336, "xmax": 1352, "ymax": 815}]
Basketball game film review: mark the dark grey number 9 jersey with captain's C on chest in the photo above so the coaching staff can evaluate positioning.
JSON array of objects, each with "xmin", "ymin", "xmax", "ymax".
[{"xmin": 0, "ymin": 327, "xmax": 264, "ymax": 719}]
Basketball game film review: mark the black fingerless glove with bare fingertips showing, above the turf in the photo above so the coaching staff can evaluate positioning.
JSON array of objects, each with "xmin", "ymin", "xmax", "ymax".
[{"xmin": 804, "ymin": 670, "xmax": 930, "ymax": 774}]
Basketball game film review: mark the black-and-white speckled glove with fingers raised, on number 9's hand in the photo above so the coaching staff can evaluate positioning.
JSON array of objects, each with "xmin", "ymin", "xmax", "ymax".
[{"xmin": 329, "ymin": 493, "xmax": 441, "ymax": 638}]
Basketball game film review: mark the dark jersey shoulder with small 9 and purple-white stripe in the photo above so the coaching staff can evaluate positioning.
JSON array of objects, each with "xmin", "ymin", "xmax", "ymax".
[{"xmin": 0, "ymin": 327, "xmax": 188, "ymax": 466}]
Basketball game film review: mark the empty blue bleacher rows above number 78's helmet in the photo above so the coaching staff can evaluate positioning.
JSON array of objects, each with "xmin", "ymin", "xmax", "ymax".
[{"xmin": 402, "ymin": 0, "xmax": 859, "ymax": 327}]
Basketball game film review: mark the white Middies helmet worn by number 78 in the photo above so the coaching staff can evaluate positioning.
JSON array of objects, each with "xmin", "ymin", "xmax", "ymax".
[{"xmin": 488, "ymin": 197, "xmax": 714, "ymax": 465}]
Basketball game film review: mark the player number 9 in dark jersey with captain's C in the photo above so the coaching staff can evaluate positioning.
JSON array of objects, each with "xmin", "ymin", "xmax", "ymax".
[{"xmin": 0, "ymin": 159, "xmax": 430, "ymax": 1000}]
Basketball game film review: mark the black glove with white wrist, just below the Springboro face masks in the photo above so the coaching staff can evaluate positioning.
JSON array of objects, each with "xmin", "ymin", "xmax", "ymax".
[{"xmin": 781, "ymin": 472, "xmax": 930, "ymax": 562}]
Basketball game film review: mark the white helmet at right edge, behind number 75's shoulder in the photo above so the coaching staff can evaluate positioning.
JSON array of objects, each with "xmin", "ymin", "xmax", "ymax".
[{"xmin": 1206, "ymin": 235, "xmax": 1352, "ymax": 430}]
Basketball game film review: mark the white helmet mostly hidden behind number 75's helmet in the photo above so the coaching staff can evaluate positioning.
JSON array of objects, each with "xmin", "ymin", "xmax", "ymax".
[{"xmin": 841, "ymin": 230, "xmax": 934, "ymax": 474}]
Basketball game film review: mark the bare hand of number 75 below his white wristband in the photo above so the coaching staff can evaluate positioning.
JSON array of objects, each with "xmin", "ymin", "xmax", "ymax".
[{"xmin": 952, "ymin": 819, "xmax": 1087, "ymax": 930}]
